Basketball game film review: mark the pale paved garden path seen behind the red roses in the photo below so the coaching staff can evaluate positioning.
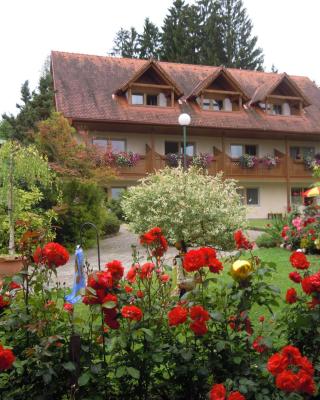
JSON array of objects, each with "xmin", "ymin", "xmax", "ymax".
[{"xmin": 58, "ymin": 224, "xmax": 261, "ymax": 287}]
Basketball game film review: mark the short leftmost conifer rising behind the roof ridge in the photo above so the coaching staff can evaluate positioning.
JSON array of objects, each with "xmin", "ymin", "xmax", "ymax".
[{"xmin": 113, "ymin": 27, "xmax": 139, "ymax": 58}]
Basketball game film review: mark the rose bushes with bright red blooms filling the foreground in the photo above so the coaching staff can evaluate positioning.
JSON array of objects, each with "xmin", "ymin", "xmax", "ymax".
[{"xmin": 0, "ymin": 227, "xmax": 320, "ymax": 400}]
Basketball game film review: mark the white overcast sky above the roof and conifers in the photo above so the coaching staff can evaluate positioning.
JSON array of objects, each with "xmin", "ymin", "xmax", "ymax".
[{"xmin": 0, "ymin": 0, "xmax": 320, "ymax": 114}]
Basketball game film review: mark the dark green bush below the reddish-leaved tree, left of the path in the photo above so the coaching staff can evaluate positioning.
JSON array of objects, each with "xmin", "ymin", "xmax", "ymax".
[{"xmin": 57, "ymin": 180, "xmax": 108, "ymax": 247}]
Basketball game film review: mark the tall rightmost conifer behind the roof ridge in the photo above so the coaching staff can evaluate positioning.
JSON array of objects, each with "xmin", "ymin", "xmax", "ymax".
[{"xmin": 217, "ymin": 0, "xmax": 264, "ymax": 70}]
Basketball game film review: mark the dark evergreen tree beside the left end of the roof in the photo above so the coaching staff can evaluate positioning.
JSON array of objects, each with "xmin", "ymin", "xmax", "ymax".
[{"xmin": 2, "ymin": 61, "xmax": 54, "ymax": 142}]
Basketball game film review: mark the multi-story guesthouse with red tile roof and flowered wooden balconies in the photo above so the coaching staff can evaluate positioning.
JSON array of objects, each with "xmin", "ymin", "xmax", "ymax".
[{"xmin": 51, "ymin": 52, "xmax": 320, "ymax": 218}]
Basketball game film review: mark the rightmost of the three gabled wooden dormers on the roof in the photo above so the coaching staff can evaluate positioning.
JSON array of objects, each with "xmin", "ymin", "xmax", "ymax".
[{"xmin": 250, "ymin": 73, "xmax": 310, "ymax": 116}]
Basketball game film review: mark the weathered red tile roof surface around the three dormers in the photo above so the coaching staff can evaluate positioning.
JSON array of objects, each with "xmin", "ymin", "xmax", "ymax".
[{"xmin": 52, "ymin": 51, "xmax": 320, "ymax": 134}]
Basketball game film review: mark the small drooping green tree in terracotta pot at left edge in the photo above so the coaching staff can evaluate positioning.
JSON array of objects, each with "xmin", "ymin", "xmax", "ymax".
[{"xmin": 0, "ymin": 140, "xmax": 51, "ymax": 276}]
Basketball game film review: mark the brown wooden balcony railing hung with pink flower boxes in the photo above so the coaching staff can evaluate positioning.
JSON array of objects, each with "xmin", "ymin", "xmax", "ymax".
[{"xmin": 118, "ymin": 146, "xmax": 312, "ymax": 180}]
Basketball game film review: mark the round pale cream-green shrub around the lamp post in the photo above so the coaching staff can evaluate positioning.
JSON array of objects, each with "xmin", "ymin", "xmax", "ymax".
[{"xmin": 122, "ymin": 167, "xmax": 246, "ymax": 249}]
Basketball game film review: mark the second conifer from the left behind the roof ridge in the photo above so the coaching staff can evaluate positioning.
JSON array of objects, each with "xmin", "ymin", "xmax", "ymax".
[{"xmin": 138, "ymin": 18, "xmax": 161, "ymax": 60}]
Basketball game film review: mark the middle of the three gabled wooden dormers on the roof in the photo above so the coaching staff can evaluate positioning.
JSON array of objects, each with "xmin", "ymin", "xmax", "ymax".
[{"xmin": 188, "ymin": 67, "xmax": 249, "ymax": 111}]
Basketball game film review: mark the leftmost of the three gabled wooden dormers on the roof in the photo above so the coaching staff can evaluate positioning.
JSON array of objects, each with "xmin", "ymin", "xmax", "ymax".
[{"xmin": 116, "ymin": 60, "xmax": 183, "ymax": 107}]
